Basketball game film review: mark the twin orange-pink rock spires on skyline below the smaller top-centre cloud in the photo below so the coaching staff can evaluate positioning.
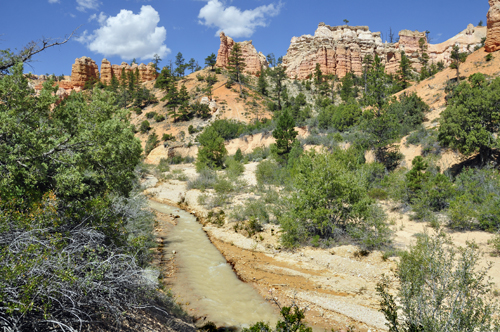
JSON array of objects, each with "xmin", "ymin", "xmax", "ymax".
[{"xmin": 215, "ymin": 32, "xmax": 268, "ymax": 75}]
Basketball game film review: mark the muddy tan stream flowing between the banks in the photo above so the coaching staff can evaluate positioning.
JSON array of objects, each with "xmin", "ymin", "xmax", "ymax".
[{"xmin": 149, "ymin": 201, "xmax": 278, "ymax": 327}]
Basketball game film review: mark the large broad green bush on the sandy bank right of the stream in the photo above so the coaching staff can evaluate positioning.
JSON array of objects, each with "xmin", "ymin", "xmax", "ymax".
[{"xmin": 278, "ymin": 149, "xmax": 389, "ymax": 248}]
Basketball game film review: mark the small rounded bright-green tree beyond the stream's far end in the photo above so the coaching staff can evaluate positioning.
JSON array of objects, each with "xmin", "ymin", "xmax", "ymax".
[{"xmin": 196, "ymin": 126, "xmax": 227, "ymax": 171}]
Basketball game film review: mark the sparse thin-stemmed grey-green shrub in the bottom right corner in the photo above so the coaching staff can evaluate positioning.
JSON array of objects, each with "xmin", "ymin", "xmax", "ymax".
[{"xmin": 377, "ymin": 234, "xmax": 499, "ymax": 332}]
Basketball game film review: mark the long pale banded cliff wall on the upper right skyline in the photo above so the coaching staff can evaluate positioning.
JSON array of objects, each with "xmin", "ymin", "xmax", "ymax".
[{"xmin": 283, "ymin": 22, "xmax": 486, "ymax": 79}]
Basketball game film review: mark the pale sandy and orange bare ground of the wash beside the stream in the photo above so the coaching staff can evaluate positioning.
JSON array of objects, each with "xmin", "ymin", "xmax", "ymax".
[{"xmin": 143, "ymin": 163, "xmax": 500, "ymax": 331}]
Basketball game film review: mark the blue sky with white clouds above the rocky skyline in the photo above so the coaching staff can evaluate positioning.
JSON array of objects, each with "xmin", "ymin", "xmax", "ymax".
[{"xmin": 0, "ymin": 0, "xmax": 489, "ymax": 75}]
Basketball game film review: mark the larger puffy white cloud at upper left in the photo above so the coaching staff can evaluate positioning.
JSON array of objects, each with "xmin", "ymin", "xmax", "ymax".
[{"xmin": 77, "ymin": 5, "xmax": 170, "ymax": 60}]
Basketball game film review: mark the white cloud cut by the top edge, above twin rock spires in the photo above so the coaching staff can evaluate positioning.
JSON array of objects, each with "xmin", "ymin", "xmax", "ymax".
[{"xmin": 198, "ymin": 0, "xmax": 281, "ymax": 38}]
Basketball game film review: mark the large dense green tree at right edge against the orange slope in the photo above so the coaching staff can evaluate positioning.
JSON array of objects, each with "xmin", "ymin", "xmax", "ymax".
[{"xmin": 438, "ymin": 73, "xmax": 500, "ymax": 165}]
